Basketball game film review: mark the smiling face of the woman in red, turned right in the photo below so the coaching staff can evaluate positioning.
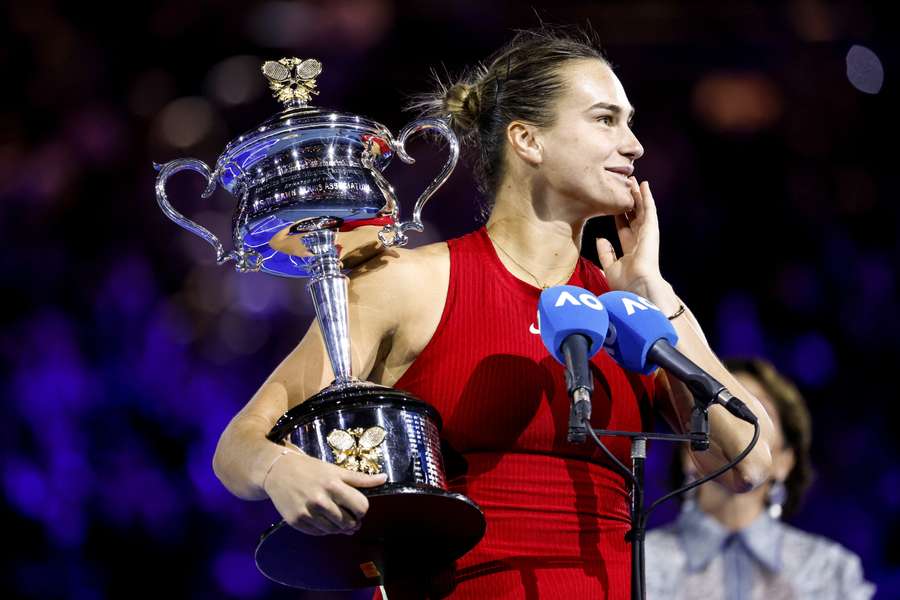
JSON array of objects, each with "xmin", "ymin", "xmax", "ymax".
[{"xmin": 536, "ymin": 59, "xmax": 644, "ymax": 216}]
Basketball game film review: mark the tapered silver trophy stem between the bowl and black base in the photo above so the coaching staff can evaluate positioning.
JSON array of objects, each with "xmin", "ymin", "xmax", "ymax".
[{"xmin": 301, "ymin": 229, "xmax": 355, "ymax": 385}]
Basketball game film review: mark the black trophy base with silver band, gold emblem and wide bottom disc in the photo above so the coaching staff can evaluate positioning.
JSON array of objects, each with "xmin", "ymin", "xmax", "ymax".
[{"xmin": 256, "ymin": 380, "xmax": 486, "ymax": 590}]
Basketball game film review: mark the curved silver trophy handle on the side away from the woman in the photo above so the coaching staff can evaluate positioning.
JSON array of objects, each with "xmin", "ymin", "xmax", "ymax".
[{"xmin": 153, "ymin": 158, "xmax": 262, "ymax": 272}]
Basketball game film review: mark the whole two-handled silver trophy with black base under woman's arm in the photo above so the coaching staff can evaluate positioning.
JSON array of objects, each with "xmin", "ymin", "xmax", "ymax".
[{"xmin": 154, "ymin": 58, "xmax": 485, "ymax": 590}]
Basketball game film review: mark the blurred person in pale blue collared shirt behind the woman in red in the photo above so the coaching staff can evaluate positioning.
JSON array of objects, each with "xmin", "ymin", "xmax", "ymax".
[{"xmin": 646, "ymin": 358, "xmax": 875, "ymax": 600}]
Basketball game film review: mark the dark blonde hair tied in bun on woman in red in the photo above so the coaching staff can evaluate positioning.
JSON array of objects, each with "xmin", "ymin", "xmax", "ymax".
[{"xmin": 410, "ymin": 25, "xmax": 609, "ymax": 216}]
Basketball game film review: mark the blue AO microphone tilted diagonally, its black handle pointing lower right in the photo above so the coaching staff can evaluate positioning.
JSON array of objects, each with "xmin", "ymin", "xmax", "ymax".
[{"xmin": 600, "ymin": 291, "xmax": 756, "ymax": 423}]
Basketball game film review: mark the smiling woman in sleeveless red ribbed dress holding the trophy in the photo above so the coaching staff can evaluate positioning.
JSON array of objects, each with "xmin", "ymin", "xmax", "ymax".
[{"xmin": 213, "ymin": 28, "xmax": 773, "ymax": 600}]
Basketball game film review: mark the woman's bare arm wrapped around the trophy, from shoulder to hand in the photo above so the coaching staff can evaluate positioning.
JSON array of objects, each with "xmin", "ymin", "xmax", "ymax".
[{"xmin": 213, "ymin": 248, "xmax": 450, "ymax": 534}]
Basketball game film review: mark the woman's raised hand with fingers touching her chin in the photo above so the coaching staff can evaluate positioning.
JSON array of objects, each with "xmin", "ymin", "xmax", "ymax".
[{"xmin": 597, "ymin": 177, "xmax": 663, "ymax": 300}]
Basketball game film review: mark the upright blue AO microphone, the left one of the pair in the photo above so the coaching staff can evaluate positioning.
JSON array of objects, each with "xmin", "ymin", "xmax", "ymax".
[{"xmin": 538, "ymin": 285, "xmax": 609, "ymax": 443}]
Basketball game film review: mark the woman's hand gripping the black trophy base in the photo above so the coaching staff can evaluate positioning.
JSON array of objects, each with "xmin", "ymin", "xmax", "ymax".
[{"xmin": 263, "ymin": 452, "xmax": 387, "ymax": 535}]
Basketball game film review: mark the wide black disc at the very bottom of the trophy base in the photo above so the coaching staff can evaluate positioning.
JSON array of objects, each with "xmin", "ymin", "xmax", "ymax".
[{"xmin": 255, "ymin": 483, "xmax": 485, "ymax": 590}]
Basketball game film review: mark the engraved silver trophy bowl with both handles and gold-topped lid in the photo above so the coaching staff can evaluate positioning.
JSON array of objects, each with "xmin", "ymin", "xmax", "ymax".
[{"xmin": 154, "ymin": 59, "xmax": 459, "ymax": 277}]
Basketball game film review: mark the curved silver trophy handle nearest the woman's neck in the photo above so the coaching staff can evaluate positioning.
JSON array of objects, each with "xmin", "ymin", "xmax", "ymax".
[{"xmin": 378, "ymin": 118, "xmax": 459, "ymax": 247}]
